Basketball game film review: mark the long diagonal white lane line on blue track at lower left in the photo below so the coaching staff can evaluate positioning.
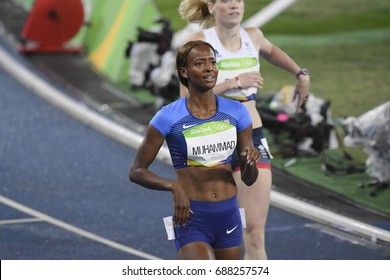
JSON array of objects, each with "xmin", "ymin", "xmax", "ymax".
[{"xmin": 0, "ymin": 195, "xmax": 161, "ymax": 260}]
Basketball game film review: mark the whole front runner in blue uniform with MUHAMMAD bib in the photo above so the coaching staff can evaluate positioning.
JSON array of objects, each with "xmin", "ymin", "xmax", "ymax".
[{"xmin": 129, "ymin": 41, "xmax": 260, "ymax": 259}]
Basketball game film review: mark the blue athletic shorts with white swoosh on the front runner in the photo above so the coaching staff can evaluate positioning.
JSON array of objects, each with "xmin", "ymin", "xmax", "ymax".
[{"xmin": 174, "ymin": 196, "xmax": 242, "ymax": 251}]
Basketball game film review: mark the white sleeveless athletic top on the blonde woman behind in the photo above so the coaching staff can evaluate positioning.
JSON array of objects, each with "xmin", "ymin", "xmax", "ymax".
[{"xmin": 203, "ymin": 27, "xmax": 260, "ymax": 102}]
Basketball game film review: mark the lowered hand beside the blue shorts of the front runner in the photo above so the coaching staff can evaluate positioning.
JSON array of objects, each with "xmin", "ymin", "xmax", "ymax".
[{"xmin": 172, "ymin": 182, "xmax": 191, "ymax": 226}]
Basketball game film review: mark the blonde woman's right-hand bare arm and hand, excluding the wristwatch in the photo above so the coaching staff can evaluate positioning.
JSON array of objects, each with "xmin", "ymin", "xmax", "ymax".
[{"xmin": 248, "ymin": 28, "xmax": 310, "ymax": 112}]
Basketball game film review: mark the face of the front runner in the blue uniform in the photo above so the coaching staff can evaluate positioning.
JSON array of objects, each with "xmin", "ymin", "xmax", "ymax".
[{"xmin": 183, "ymin": 45, "xmax": 218, "ymax": 90}]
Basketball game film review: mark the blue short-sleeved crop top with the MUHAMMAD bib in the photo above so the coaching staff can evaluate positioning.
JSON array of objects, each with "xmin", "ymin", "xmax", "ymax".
[{"xmin": 150, "ymin": 95, "xmax": 252, "ymax": 169}]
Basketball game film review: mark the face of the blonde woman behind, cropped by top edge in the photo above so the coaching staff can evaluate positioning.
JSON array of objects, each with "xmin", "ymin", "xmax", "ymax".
[{"xmin": 208, "ymin": 0, "xmax": 244, "ymax": 27}]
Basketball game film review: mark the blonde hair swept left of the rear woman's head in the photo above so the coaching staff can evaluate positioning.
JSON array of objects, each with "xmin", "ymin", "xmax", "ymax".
[{"xmin": 178, "ymin": 0, "xmax": 216, "ymax": 28}]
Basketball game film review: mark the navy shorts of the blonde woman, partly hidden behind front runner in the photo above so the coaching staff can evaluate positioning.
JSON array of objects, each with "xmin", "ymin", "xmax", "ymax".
[{"xmin": 232, "ymin": 127, "xmax": 271, "ymax": 172}]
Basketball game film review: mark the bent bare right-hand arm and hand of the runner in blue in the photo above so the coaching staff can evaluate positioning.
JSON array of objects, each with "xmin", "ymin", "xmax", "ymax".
[{"xmin": 238, "ymin": 124, "xmax": 261, "ymax": 186}]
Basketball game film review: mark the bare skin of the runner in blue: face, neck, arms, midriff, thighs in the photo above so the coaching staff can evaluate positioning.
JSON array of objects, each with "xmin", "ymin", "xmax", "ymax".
[{"xmin": 129, "ymin": 45, "xmax": 260, "ymax": 260}]
